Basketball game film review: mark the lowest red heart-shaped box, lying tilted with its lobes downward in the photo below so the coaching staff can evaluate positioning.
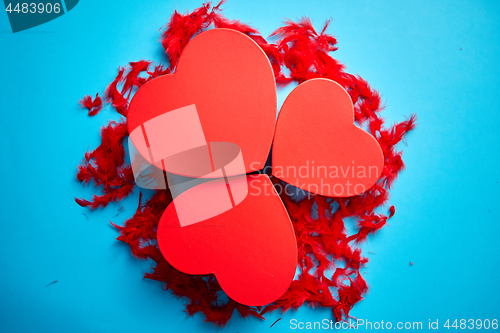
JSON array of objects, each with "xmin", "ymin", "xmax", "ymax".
[{"xmin": 157, "ymin": 174, "xmax": 297, "ymax": 306}]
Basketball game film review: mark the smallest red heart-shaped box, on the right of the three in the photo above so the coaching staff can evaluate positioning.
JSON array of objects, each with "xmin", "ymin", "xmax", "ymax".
[{"xmin": 272, "ymin": 79, "xmax": 384, "ymax": 197}]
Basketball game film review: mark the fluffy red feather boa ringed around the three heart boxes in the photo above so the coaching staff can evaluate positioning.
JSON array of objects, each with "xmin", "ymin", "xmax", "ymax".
[{"xmin": 76, "ymin": 3, "xmax": 415, "ymax": 326}]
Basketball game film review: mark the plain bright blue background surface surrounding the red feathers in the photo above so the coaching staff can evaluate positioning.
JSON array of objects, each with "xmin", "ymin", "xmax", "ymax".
[{"xmin": 0, "ymin": 0, "xmax": 500, "ymax": 332}]
